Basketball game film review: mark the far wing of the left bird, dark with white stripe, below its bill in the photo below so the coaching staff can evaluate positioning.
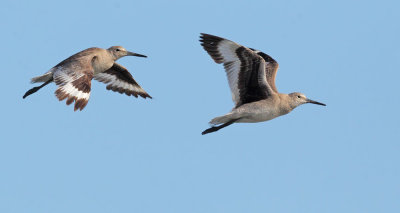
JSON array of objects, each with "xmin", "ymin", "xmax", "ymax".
[{"xmin": 94, "ymin": 63, "xmax": 151, "ymax": 98}]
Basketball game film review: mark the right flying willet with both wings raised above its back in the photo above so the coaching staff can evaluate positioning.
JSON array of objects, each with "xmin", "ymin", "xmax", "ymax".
[{"xmin": 200, "ymin": 33, "xmax": 326, "ymax": 135}]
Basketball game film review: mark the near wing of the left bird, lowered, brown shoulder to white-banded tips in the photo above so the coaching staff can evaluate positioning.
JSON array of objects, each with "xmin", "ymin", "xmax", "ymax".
[{"xmin": 53, "ymin": 57, "xmax": 96, "ymax": 111}]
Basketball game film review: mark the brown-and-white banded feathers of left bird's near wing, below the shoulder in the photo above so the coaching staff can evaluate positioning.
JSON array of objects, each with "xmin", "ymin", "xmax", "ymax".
[{"xmin": 53, "ymin": 66, "xmax": 93, "ymax": 111}]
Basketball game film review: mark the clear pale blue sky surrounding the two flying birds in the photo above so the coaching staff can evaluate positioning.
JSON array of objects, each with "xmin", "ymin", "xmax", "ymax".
[{"xmin": 0, "ymin": 0, "xmax": 400, "ymax": 213}]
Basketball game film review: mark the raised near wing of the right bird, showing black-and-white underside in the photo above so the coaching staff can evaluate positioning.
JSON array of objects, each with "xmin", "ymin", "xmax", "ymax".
[{"xmin": 200, "ymin": 33, "xmax": 273, "ymax": 107}]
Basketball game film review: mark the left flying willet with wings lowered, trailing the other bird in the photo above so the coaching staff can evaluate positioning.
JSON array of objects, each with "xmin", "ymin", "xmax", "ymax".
[{"xmin": 23, "ymin": 46, "xmax": 151, "ymax": 111}]
